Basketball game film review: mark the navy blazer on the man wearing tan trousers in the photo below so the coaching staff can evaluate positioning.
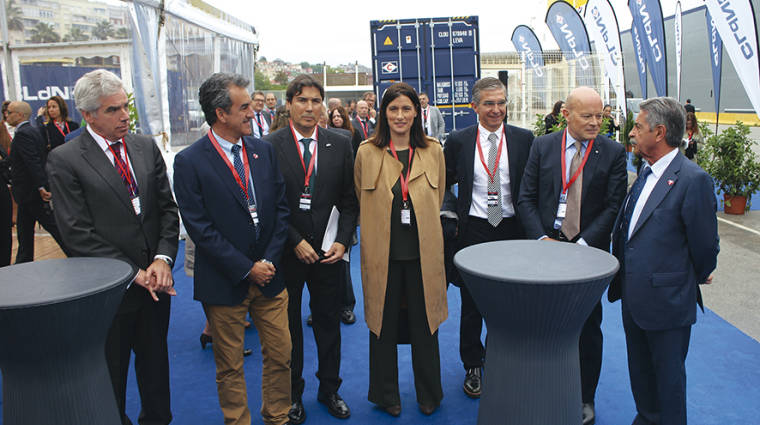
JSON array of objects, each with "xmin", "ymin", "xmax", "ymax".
[{"xmin": 174, "ymin": 136, "xmax": 288, "ymax": 305}]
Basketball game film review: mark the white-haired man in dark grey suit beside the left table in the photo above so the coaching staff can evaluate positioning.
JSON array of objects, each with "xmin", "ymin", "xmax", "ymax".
[{"xmin": 47, "ymin": 69, "xmax": 179, "ymax": 425}]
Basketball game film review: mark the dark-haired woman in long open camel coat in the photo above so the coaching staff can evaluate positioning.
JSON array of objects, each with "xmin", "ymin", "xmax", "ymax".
[{"xmin": 354, "ymin": 83, "xmax": 448, "ymax": 416}]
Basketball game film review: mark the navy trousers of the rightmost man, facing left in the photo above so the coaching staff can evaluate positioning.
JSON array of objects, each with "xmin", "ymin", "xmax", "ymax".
[{"xmin": 623, "ymin": 304, "xmax": 691, "ymax": 425}]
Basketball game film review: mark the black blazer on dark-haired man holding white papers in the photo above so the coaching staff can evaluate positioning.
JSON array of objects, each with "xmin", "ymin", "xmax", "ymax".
[{"xmin": 264, "ymin": 127, "xmax": 359, "ymax": 252}]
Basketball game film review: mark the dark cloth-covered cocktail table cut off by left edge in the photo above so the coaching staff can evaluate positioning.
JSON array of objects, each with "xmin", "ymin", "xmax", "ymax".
[{"xmin": 0, "ymin": 258, "xmax": 134, "ymax": 425}]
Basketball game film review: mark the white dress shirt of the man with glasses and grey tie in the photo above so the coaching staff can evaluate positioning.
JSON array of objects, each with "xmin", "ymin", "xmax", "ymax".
[{"xmin": 466, "ymin": 121, "xmax": 515, "ymax": 219}]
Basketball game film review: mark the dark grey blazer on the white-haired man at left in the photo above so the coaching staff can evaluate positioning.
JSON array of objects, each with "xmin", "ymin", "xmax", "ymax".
[{"xmin": 46, "ymin": 131, "xmax": 179, "ymax": 302}]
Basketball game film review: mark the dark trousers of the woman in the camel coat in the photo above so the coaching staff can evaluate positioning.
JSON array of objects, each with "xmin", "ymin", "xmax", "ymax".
[{"xmin": 367, "ymin": 260, "xmax": 443, "ymax": 407}]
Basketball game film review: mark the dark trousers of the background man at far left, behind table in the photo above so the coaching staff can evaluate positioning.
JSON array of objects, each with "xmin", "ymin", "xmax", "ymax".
[{"xmin": 16, "ymin": 199, "xmax": 66, "ymax": 264}]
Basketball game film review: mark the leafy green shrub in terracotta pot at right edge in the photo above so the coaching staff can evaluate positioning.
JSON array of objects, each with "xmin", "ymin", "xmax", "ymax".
[{"xmin": 697, "ymin": 121, "xmax": 760, "ymax": 214}]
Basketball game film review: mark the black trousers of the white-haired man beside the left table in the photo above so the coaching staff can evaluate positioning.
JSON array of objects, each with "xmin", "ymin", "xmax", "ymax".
[{"xmin": 106, "ymin": 283, "xmax": 172, "ymax": 425}]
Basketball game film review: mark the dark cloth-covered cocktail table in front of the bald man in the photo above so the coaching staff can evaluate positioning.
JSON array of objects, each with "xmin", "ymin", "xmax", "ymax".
[{"xmin": 454, "ymin": 240, "xmax": 618, "ymax": 425}]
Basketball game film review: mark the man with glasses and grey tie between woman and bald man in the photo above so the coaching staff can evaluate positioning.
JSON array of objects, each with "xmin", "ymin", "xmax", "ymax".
[{"xmin": 443, "ymin": 77, "xmax": 533, "ymax": 398}]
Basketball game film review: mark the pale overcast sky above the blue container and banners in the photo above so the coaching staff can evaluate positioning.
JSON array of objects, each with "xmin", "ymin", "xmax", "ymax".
[{"xmin": 206, "ymin": 0, "xmax": 703, "ymax": 67}]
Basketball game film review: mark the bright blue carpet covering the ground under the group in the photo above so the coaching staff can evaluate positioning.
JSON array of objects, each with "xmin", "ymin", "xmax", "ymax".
[{"xmin": 0, "ymin": 238, "xmax": 760, "ymax": 425}]
